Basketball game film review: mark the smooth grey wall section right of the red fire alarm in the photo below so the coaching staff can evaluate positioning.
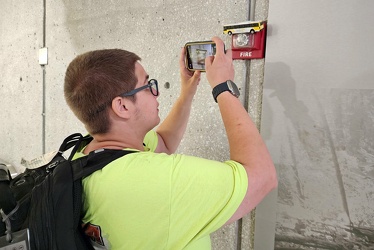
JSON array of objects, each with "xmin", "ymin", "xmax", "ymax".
[{"xmin": 262, "ymin": 0, "xmax": 374, "ymax": 249}]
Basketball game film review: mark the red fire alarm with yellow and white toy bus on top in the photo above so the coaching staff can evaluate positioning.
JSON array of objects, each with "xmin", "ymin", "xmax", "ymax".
[{"xmin": 223, "ymin": 21, "xmax": 267, "ymax": 60}]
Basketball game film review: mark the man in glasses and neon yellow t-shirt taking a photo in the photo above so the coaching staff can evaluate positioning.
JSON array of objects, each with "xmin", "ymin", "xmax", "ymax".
[{"xmin": 65, "ymin": 37, "xmax": 277, "ymax": 249}]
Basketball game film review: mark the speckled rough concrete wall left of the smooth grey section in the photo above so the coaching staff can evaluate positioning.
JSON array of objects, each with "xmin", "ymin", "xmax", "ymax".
[{"xmin": 0, "ymin": 0, "xmax": 273, "ymax": 249}]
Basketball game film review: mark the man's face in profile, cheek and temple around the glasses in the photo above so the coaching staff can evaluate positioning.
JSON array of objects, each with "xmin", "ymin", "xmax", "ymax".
[{"xmin": 135, "ymin": 62, "xmax": 160, "ymax": 132}]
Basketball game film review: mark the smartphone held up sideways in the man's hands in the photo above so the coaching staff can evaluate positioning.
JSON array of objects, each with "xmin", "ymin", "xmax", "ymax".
[{"xmin": 185, "ymin": 41, "xmax": 216, "ymax": 71}]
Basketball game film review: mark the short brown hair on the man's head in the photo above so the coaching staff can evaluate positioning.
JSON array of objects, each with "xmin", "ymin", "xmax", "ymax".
[{"xmin": 64, "ymin": 49, "xmax": 140, "ymax": 134}]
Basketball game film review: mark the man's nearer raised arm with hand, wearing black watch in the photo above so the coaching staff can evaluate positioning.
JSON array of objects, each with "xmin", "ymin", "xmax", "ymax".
[{"xmin": 205, "ymin": 37, "xmax": 278, "ymax": 223}]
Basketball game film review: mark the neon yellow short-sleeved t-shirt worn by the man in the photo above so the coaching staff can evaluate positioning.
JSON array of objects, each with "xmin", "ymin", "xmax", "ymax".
[{"xmin": 77, "ymin": 132, "xmax": 248, "ymax": 250}]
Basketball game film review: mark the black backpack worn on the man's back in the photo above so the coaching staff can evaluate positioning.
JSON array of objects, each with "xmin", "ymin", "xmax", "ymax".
[{"xmin": 0, "ymin": 133, "xmax": 133, "ymax": 250}]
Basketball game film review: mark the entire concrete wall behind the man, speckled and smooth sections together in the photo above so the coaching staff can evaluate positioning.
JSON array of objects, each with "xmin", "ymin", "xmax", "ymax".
[{"xmin": 5, "ymin": 0, "xmax": 374, "ymax": 250}]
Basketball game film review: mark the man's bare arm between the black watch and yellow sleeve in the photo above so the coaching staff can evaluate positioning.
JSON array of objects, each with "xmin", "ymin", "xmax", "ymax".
[{"xmin": 218, "ymin": 92, "xmax": 277, "ymax": 218}]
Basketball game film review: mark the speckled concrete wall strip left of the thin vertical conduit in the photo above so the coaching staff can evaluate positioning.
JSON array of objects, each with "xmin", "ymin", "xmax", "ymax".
[{"xmin": 0, "ymin": 1, "xmax": 43, "ymax": 168}]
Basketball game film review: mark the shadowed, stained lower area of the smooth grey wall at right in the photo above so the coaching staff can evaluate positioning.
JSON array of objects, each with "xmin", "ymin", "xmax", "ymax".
[{"xmin": 262, "ymin": 62, "xmax": 374, "ymax": 249}]
